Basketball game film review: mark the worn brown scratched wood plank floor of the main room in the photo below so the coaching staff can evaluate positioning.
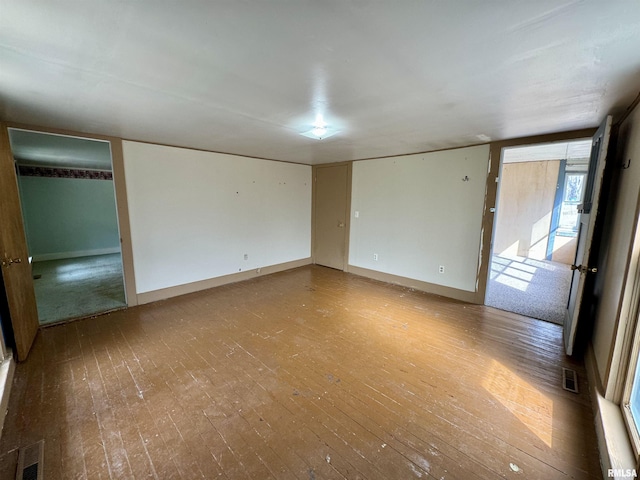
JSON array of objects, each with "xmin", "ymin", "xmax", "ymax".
[{"xmin": 0, "ymin": 266, "xmax": 602, "ymax": 480}]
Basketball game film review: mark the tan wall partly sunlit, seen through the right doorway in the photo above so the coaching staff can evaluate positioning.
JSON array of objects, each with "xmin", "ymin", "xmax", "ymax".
[{"xmin": 493, "ymin": 160, "xmax": 560, "ymax": 260}]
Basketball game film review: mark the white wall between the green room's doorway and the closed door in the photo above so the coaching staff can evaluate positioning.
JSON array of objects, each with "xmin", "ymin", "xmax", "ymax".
[{"xmin": 123, "ymin": 141, "xmax": 311, "ymax": 293}]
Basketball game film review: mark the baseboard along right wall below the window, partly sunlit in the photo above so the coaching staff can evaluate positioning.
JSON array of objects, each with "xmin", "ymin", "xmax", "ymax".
[{"xmin": 585, "ymin": 342, "xmax": 636, "ymax": 478}]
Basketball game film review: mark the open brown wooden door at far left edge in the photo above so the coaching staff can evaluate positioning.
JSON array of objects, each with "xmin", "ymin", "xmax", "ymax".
[{"xmin": 0, "ymin": 124, "xmax": 39, "ymax": 360}]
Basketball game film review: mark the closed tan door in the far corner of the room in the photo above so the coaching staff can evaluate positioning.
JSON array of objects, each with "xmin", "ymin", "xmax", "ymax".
[{"xmin": 313, "ymin": 165, "xmax": 350, "ymax": 270}]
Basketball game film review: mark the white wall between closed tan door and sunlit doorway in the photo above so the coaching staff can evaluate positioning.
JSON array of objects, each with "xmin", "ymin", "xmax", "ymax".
[{"xmin": 349, "ymin": 145, "xmax": 489, "ymax": 292}]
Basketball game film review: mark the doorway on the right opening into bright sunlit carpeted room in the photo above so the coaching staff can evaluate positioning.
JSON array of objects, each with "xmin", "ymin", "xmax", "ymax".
[{"xmin": 485, "ymin": 139, "xmax": 592, "ymax": 325}]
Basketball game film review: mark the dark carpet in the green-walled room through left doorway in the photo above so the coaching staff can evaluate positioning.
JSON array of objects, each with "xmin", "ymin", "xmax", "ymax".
[{"xmin": 32, "ymin": 253, "xmax": 126, "ymax": 324}]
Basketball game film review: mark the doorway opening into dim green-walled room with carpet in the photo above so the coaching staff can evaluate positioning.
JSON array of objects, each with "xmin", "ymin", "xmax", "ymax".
[{"xmin": 9, "ymin": 128, "xmax": 127, "ymax": 325}]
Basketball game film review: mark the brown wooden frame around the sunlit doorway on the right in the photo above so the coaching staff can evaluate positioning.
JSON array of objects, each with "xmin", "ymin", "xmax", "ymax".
[{"xmin": 475, "ymin": 128, "xmax": 597, "ymax": 305}]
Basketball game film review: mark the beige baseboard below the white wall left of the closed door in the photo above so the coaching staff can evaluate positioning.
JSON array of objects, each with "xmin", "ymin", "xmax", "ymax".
[{"xmin": 137, "ymin": 257, "xmax": 311, "ymax": 305}]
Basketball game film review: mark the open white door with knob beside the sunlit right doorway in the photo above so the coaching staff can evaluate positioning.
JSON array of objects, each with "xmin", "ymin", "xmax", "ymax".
[{"xmin": 564, "ymin": 116, "xmax": 611, "ymax": 355}]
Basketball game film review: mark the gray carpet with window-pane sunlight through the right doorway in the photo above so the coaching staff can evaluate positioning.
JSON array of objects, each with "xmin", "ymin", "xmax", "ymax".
[{"xmin": 485, "ymin": 255, "xmax": 571, "ymax": 325}]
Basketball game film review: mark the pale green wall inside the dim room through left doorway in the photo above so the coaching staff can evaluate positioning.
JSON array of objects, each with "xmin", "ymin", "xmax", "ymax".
[{"xmin": 19, "ymin": 176, "xmax": 120, "ymax": 261}]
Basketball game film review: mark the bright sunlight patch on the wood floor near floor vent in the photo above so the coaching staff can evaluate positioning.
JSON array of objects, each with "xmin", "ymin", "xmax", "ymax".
[{"xmin": 482, "ymin": 359, "xmax": 553, "ymax": 447}]
